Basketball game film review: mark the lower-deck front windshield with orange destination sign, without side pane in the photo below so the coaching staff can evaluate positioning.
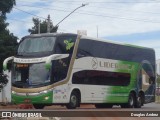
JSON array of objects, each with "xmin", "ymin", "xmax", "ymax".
[{"xmin": 12, "ymin": 63, "xmax": 51, "ymax": 88}]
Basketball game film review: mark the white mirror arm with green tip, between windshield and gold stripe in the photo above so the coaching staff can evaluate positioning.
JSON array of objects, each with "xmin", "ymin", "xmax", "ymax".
[{"xmin": 45, "ymin": 54, "xmax": 69, "ymax": 69}]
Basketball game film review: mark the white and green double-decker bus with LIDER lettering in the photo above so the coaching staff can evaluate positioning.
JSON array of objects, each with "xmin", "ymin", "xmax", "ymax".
[{"xmin": 3, "ymin": 33, "xmax": 156, "ymax": 109}]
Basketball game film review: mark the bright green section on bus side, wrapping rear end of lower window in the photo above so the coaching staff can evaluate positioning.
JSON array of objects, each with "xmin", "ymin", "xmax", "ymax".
[{"xmin": 105, "ymin": 61, "xmax": 139, "ymax": 103}]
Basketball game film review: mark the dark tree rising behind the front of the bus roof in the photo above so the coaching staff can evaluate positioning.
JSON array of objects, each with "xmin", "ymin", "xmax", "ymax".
[{"xmin": 28, "ymin": 18, "xmax": 58, "ymax": 34}]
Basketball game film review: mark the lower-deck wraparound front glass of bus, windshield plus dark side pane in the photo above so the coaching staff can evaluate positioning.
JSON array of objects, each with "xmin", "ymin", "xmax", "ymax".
[{"xmin": 12, "ymin": 57, "xmax": 70, "ymax": 88}]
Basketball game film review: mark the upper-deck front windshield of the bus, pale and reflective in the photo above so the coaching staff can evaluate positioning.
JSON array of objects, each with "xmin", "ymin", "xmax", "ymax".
[{"xmin": 18, "ymin": 37, "xmax": 56, "ymax": 55}]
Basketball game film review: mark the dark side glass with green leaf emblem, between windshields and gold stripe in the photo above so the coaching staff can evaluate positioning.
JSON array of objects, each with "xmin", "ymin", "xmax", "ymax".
[{"xmin": 51, "ymin": 35, "xmax": 77, "ymax": 82}]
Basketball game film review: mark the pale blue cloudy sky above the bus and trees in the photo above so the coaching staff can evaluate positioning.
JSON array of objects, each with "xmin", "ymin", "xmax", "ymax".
[{"xmin": 7, "ymin": 0, "xmax": 160, "ymax": 59}]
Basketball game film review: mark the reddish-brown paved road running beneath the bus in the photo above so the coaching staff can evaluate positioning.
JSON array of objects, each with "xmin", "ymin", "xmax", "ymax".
[{"xmin": 1, "ymin": 103, "xmax": 160, "ymax": 120}]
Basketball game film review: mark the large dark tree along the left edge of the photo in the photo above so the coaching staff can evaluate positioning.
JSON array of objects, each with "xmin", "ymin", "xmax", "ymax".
[{"xmin": 0, "ymin": 0, "xmax": 18, "ymax": 73}]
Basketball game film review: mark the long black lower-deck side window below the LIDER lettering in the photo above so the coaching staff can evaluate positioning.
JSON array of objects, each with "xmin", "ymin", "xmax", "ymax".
[{"xmin": 72, "ymin": 70, "xmax": 131, "ymax": 86}]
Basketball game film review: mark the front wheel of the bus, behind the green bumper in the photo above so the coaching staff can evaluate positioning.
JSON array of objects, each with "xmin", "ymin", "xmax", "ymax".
[{"xmin": 66, "ymin": 91, "xmax": 79, "ymax": 109}]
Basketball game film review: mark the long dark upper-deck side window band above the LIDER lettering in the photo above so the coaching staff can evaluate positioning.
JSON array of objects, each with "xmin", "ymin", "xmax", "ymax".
[{"xmin": 77, "ymin": 39, "xmax": 155, "ymax": 70}]
